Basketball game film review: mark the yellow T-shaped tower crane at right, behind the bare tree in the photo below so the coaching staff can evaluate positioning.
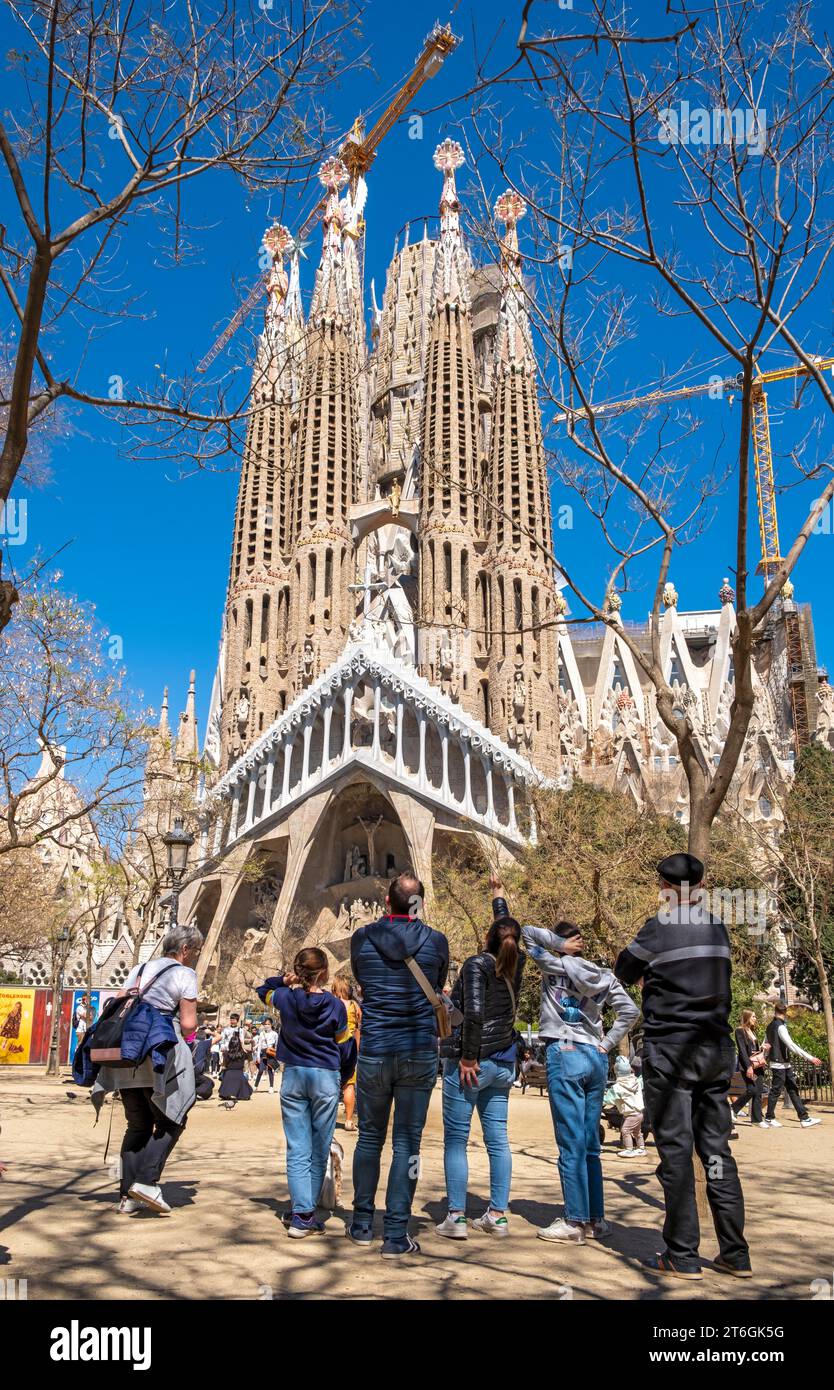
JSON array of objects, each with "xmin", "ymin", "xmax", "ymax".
[{"xmin": 555, "ymin": 357, "xmax": 834, "ymax": 585}]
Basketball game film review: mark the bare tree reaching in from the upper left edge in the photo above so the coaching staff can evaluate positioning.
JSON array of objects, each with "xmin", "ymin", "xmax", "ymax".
[{"xmin": 0, "ymin": 0, "xmax": 359, "ymax": 627}]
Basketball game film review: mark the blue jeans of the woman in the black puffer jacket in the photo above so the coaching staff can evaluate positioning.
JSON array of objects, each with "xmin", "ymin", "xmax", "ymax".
[{"xmin": 443, "ymin": 1058, "xmax": 516, "ymax": 1212}]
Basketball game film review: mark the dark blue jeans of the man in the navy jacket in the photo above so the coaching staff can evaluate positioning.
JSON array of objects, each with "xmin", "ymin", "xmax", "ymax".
[{"xmin": 353, "ymin": 1049, "xmax": 438, "ymax": 1240}]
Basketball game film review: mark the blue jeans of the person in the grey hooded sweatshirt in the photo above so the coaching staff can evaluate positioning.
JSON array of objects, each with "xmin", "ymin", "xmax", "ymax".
[{"xmin": 546, "ymin": 1043, "xmax": 607, "ymax": 1222}]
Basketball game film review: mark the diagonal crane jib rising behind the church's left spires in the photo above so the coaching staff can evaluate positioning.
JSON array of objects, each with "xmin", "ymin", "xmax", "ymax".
[{"xmin": 197, "ymin": 24, "xmax": 460, "ymax": 373}]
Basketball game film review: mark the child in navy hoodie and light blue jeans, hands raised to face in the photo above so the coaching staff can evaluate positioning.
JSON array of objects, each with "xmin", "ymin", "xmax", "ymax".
[{"xmin": 256, "ymin": 947, "xmax": 350, "ymax": 1240}]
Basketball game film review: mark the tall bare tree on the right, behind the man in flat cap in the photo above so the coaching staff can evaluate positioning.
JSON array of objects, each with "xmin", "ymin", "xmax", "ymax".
[{"xmin": 430, "ymin": 0, "xmax": 834, "ymax": 858}]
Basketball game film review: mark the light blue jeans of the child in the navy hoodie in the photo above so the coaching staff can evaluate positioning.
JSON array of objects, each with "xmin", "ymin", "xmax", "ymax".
[{"xmin": 281, "ymin": 1066, "xmax": 339, "ymax": 1212}]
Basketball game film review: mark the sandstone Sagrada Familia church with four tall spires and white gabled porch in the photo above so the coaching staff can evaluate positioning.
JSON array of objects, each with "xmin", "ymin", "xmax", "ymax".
[{"xmin": 140, "ymin": 140, "xmax": 834, "ymax": 988}]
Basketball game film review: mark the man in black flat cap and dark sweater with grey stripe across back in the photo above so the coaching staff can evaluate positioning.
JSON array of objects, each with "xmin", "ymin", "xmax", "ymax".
[{"xmin": 614, "ymin": 853, "xmax": 751, "ymax": 1279}]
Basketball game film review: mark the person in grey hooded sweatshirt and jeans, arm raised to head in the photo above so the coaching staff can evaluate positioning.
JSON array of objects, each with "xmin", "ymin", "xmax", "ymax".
[{"xmin": 489, "ymin": 876, "xmax": 639, "ymax": 1245}]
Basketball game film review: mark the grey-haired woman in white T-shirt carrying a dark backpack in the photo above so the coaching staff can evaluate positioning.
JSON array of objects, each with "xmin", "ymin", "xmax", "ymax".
[{"xmin": 90, "ymin": 926, "xmax": 203, "ymax": 1216}]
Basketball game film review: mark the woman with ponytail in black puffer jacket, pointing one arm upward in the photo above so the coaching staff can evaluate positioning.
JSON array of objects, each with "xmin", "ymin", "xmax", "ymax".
[{"xmin": 436, "ymin": 895, "xmax": 525, "ymax": 1240}]
